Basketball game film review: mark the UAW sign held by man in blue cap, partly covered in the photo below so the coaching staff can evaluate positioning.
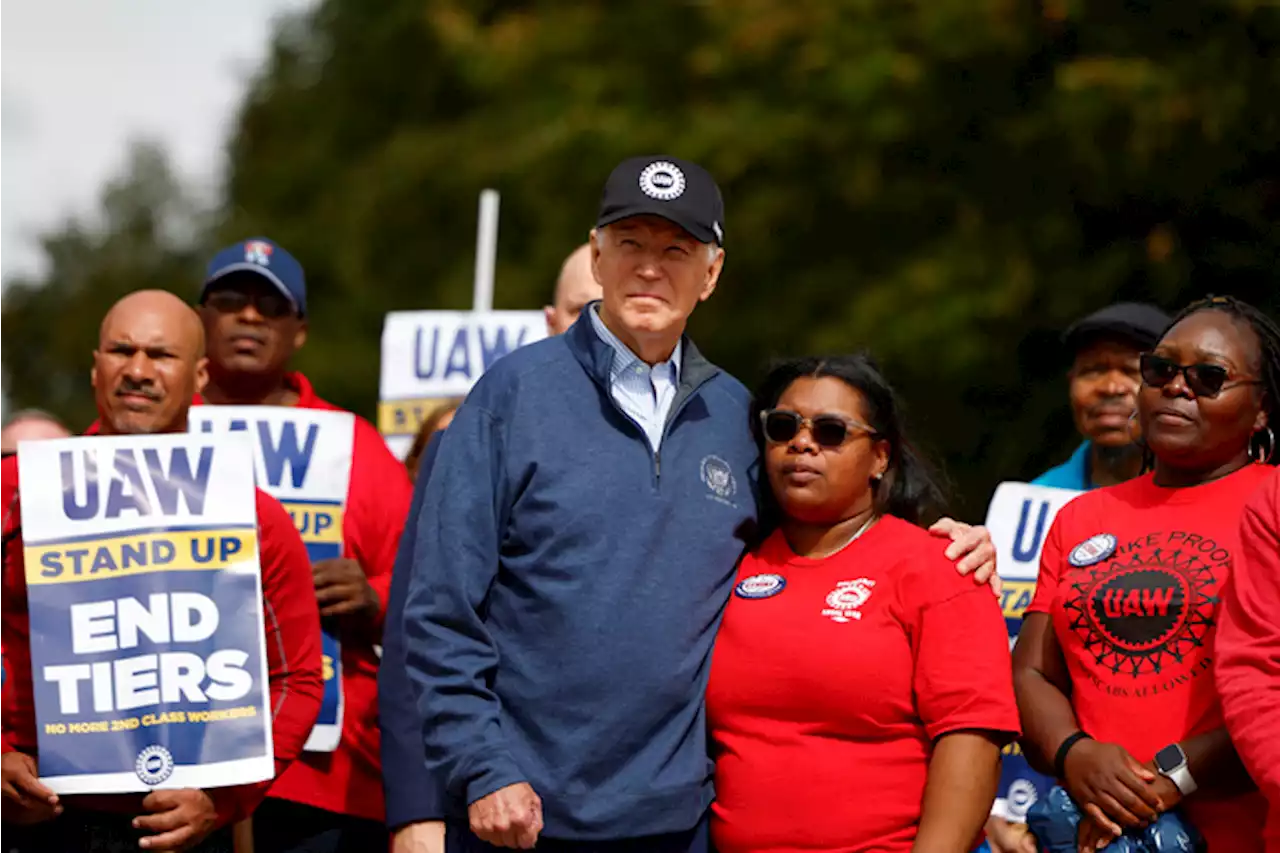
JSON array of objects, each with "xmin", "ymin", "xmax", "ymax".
[{"xmin": 189, "ymin": 406, "xmax": 356, "ymax": 752}]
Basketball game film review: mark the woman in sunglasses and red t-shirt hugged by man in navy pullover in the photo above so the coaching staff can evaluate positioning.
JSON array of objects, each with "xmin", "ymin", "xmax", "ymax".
[{"xmin": 707, "ymin": 356, "xmax": 1018, "ymax": 853}]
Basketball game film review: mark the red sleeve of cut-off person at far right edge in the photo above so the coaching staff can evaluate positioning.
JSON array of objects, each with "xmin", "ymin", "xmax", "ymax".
[{"xmin": 1215, "ymin": 475, "xmax": 1280, "ymax": 803}]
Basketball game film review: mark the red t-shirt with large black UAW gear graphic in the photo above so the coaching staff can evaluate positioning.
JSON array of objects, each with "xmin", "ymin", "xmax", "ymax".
[{"xmin": 1027, "ymin": 465, "xmax": 1272, "ymax": 853}]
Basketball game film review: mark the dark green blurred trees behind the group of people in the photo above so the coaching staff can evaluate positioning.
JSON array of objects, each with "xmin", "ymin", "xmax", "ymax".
[{"xmin": 0, "ymin": 0, "xmax": 1280, "ymax": 516}]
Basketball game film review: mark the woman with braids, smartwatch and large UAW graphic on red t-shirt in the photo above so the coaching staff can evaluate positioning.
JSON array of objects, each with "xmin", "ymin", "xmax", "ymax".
[{"xmin": 1014, "ymin": 298, "xmax": 1280, "ymax": 853}]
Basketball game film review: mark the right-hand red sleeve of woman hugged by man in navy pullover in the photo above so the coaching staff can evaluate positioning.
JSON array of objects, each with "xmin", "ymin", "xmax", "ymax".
[{"xmin": 902, "ymin": 543, "xmax": 1021, "ymax": 740}]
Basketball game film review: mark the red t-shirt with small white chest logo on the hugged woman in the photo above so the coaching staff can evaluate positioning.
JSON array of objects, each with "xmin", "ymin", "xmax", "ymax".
[{"xmin": 707, "ymin": 517, "xmax": 1019, "ymax": 853}]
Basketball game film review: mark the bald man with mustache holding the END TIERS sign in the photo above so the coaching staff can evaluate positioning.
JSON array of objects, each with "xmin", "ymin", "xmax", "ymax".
[{"xmin": 0, "ymin": 291, "xmax": 321, "ymax": 853}]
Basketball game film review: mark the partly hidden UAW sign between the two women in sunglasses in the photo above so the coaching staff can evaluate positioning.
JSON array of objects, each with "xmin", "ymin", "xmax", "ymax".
[{"xmin": 987, "ymin": 483, "xmax": 1080, "ymax": 822}]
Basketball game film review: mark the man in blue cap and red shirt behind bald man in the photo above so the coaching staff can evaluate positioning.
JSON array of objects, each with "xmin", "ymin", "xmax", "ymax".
[{"xmin": 200, "ymin": 238, "xmax": 412, "ymax": 853}]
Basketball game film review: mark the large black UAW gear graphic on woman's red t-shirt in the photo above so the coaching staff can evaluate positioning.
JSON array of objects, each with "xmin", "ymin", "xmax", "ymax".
[{"xmin": 1064, "ymin": 530, "xmax": 1231, "ymax": 697}]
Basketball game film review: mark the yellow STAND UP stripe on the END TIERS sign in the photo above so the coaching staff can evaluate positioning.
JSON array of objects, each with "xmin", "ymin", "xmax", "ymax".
[{"xmin": 23, "ymin": 528, "xmax": 257, "ymax": 585}]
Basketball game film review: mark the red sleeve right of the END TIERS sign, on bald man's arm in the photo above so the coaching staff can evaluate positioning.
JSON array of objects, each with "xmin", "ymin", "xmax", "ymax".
[{"xmin": 210, "ymin": 492, "xmax": 324, "ymax": 824}]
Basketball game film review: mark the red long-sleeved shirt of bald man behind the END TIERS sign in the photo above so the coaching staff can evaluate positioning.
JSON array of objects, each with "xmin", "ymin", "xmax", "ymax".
[{"xmin": 0, "ymin": 457, "xmax": 324, "ymax": 824}]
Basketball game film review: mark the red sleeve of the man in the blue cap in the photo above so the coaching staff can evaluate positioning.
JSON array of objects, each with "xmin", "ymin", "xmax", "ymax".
[{"xmin": 343, "ymin": 418, "xmax": 413, "ymax": 642}]
